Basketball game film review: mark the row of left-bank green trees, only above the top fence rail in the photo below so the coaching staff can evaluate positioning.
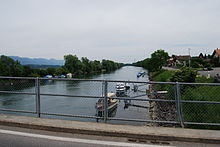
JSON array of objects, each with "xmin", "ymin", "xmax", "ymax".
[{"xmin": 0, "ymin": 55, "xmax": 123, "ymax": 77}]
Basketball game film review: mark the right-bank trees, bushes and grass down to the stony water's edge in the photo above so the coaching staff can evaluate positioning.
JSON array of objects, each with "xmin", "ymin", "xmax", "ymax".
[{"xmin": 133, "ymin": 50, "xmax": 220, "ymax": 129}]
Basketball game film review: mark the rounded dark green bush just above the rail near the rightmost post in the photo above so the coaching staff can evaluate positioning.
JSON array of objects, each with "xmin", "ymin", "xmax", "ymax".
[{"xmin": 171, "ymin": 67, "xmax": 197, "ymax": 82}]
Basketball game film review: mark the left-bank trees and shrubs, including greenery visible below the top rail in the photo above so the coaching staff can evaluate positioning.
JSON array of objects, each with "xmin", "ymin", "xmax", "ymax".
[{"xmin": 0, "ymin": 55, "xmax": 123, "ymax": 90}]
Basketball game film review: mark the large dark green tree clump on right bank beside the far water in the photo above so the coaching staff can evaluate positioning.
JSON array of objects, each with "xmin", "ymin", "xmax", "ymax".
[{"xmin": 133, "ymin": 49, "xmax": 169, "ymax": 72}]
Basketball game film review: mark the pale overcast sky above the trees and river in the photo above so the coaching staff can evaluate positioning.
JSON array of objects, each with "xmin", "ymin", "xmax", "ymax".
[{"xmin": 0, "ymin": 0, "xmax": 220, "ymax": 63}]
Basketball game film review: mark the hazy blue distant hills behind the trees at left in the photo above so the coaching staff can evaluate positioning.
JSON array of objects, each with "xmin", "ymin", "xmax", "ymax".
[{"xmin": 9, "ymin": 56, "xmax": 64, "ymax": 66}]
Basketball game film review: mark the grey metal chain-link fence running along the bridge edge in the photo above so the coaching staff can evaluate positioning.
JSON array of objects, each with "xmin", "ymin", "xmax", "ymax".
[{"xmin": 0, "ymin": 77, "xmax": 220, "ymax": 129}]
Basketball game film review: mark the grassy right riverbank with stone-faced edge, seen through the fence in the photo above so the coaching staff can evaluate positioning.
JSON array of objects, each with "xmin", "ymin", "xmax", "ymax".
[{"xmin": 150, "ymin": 70, "xmax": 220, "ymax": 129}]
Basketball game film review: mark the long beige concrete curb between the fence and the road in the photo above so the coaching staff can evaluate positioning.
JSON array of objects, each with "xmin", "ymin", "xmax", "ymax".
[{"xmin": 0, "ymin": 114, "xmax": 220, "ymax": 144}]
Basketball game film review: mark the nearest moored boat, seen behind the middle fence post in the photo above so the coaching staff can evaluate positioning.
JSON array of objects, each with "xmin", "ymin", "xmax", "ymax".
[{"xmin": 95, "ymin": 93, "xmax": 118, "ymax": 116}]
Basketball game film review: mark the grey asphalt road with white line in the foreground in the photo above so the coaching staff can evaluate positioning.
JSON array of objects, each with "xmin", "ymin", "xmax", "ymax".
[{"xmin": 0, "ymin": 126, "xmax": 219, "ymax": 147}]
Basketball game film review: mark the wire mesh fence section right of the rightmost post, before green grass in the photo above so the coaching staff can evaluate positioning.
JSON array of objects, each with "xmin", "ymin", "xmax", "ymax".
[{"xmin": 180, "ymin": 84, "xmax": 220, "ymax": 128}]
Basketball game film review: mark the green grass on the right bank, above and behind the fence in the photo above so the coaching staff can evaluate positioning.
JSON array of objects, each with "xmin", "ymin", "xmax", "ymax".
[{"xmin": 153, "ymin": 70, "xmax": 220, "ymax": 129}]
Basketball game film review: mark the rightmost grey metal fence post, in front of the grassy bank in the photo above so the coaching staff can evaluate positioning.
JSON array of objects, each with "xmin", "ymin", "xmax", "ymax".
[{"xmin": 175, "ymin": 82, "xmax": 184, "ymax": 128}]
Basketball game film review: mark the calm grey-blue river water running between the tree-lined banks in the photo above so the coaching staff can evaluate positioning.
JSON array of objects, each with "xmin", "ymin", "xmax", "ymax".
[{"xmin": 0, "ymin": 66, "xmax": 149, "ymax": 124}]
